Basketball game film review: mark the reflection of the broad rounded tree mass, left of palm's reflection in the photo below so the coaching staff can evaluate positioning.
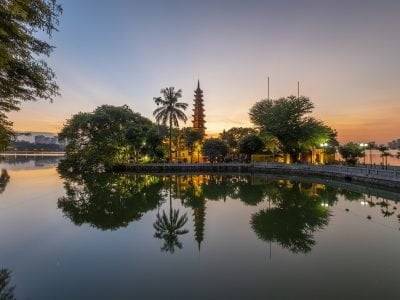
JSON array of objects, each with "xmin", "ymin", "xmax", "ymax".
[{"xmin": 58, "ymin": 171, "xmax": 163, "ymax": 230}]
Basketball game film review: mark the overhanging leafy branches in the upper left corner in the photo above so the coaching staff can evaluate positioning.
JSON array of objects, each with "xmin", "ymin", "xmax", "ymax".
[{"xmin": 0, "ymin": 0, "xmax": 62, "ymax": 149}]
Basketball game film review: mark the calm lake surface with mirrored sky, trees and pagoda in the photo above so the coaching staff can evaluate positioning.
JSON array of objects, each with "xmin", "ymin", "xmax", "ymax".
[{"xmin": 0, "ymin": 158, "xmax": 400, "ymax": 299}]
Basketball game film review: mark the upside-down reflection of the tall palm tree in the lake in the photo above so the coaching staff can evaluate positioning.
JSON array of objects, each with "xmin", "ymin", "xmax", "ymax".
[{"xmin": 153, "ymin": 177, "xmax": 189, "ymax": 253}]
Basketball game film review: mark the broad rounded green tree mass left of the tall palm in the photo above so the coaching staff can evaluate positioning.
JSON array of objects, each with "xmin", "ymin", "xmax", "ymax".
[{"xmin": 59, "ymin": 105, "xmax": 161, "ymax": 171}]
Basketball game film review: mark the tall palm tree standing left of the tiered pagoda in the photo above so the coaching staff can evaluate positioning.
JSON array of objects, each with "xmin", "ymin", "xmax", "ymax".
[{"xmin": 153, "ymin": 87, "xmax": 188, "ymax": 162}]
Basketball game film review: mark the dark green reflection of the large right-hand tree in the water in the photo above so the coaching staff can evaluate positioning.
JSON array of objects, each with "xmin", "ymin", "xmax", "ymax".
[{"xmin": 251, "ymin": 182, "xmax": 330, "ymax": 253}]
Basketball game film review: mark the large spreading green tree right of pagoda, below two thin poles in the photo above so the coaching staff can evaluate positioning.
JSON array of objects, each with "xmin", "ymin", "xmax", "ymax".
[{"xmin": 249, "ymin": 96, "xmax": 336, "ymax": 162}]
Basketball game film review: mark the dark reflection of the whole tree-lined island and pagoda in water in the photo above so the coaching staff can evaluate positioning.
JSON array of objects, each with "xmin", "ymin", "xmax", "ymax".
[{"xmin": 58, "ymin": 171, "xmax": 400, "ymax": 254}]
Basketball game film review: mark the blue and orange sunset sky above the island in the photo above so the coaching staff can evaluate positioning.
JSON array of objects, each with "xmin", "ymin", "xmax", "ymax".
[{"xmin": 10, "ymin": 0, "xmax": 400, "ymax": 143}]
